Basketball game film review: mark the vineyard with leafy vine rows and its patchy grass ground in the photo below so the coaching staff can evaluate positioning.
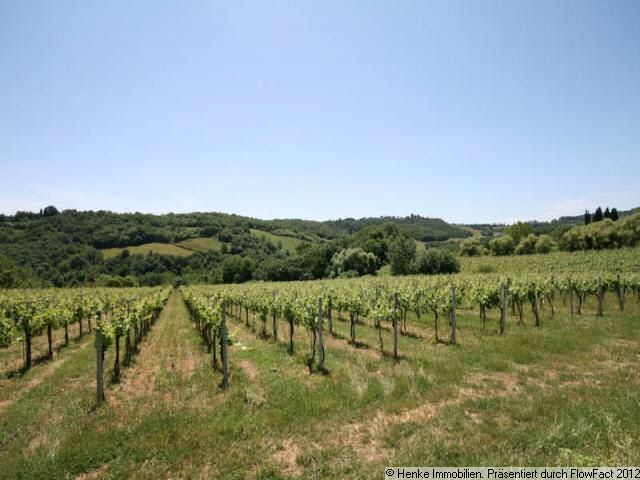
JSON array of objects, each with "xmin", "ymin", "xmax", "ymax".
[{"xmin": 0, "ymin": 258, "xmax": 640, "ymax": 478}]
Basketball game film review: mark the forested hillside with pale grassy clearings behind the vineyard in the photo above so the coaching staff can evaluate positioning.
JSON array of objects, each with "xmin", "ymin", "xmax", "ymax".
[{"xmin": 0, "ymin": 207, "xmax": 470, "ymax": 287}]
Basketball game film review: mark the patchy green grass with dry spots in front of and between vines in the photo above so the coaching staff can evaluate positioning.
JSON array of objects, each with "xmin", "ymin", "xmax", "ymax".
[{"xmin": 0, "ymin": 293, "xmax": 640, "ymax": 479}]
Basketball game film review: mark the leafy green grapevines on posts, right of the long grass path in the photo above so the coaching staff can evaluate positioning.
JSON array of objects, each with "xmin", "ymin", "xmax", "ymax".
[{"xmin": 183, "ymin": 273, "xmax": 640, "ymax": 365}]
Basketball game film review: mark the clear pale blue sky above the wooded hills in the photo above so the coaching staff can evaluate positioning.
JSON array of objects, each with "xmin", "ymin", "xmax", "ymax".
[{"xmin": 0, "ymin": 0, "xmax": 640, "ymax": 222}]
